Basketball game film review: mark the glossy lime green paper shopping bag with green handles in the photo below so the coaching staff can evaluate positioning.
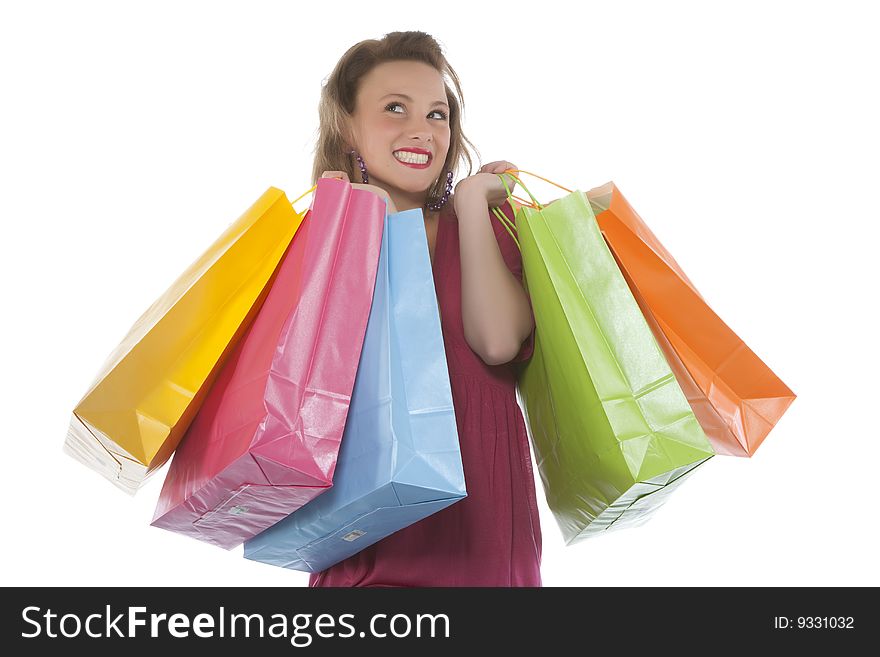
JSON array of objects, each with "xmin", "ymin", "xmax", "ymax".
[{"xmin": 496, "ymin": 169, "xmax": 714, "ymax": 545}]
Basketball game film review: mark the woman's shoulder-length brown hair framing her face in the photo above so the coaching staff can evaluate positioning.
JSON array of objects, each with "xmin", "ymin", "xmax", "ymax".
[{"xmin": 312, "ymin": 32, "xmax": 479, "ymax": 208}]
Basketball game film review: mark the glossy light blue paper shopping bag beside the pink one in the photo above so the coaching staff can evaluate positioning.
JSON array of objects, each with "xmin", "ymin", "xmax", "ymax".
[{"xmin": 244, "ymin": 210, "xmax": 467, "ymax": 572}]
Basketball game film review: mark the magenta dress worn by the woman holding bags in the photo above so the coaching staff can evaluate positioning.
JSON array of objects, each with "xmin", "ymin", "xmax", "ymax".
[{"xmin": 309, "ymin": 199, "xmax": 541, "ymax": 587}]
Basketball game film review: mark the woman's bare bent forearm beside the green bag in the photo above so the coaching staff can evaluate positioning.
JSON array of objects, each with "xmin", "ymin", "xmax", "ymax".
[{"xmin": 454, "ymin": 187, "xmax": 532, "ymax": 365}]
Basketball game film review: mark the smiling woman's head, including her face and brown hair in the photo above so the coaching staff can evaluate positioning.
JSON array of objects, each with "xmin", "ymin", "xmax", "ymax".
[{"xmin": 312, "ymin": 32, "xmax": 476, "ymax": 210}]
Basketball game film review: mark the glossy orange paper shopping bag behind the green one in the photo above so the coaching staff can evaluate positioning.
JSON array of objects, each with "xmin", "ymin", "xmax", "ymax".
[{"xmin": 587, "ymin": 183, "xmax": 795, "ymax": 456}]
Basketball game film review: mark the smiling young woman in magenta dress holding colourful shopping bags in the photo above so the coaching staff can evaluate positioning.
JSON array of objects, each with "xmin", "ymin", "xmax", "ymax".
[{"xmin": 309, "ymin": 32, "xmax": 541, "ymax": 587}]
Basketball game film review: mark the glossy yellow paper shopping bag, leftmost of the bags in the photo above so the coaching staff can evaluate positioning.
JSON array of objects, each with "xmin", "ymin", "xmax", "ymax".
[{"xmin": 64, "ymin": 187, "xmax": 304, "ymax": 494}]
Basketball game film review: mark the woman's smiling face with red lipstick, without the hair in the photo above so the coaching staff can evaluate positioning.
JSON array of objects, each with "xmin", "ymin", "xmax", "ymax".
[{"xmin": 352, "ymin": 61, "xmax": 450, "ymax": 210}]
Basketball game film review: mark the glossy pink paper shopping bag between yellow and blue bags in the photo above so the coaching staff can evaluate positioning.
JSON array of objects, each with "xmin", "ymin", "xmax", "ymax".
[{"xmin": 152, "ymin": 178, "xmax": 385, "ymax": 549}]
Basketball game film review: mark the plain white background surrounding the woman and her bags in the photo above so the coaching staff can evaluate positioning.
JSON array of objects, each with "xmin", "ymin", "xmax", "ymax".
[{"xmin": 0, "ymin": 0, "xmax": 880, "ymax": 586}]
